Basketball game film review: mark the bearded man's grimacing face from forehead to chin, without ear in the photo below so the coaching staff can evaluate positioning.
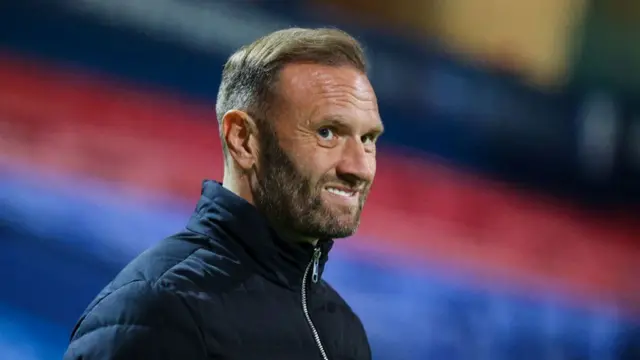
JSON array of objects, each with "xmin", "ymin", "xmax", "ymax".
[{"xmin": 252, "ymin": 64, "xmax": 382, "ymax": 239}]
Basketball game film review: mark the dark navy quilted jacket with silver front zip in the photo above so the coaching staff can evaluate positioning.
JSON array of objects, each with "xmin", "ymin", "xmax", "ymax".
[{"xmin": 64, "ymin": 181, "xmax": 371, "ymax": 360}]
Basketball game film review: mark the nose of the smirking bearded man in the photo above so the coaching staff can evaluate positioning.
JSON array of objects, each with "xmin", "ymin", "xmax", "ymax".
[{"xmin": 336, "ymin": 138, "xmax": 376, "ymax": 185}]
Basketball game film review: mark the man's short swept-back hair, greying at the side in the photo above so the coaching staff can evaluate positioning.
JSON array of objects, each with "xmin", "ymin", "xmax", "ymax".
[{"xmin": 216, "ymin": 28, "xmax": 367, "ymax": 154}]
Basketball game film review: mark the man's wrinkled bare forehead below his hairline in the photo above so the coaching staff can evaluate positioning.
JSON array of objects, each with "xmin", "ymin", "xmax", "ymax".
[{"xmin": 278, "ymin": 63, "xmax": 380, "ymax": 126}]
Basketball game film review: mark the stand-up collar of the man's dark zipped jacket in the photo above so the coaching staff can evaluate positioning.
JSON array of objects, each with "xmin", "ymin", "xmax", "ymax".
[{"xmin": 187, "ymin": 180, "xmax": 333, "ymax": 288}]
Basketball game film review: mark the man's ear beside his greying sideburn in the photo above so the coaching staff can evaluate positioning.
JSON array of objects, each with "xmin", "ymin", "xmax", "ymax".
[{"xmin": 221, "ymin": 110, "xmax": 258, "ymax": 170}]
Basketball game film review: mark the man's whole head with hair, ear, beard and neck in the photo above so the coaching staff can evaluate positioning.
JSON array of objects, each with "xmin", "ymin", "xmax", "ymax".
[{"xmin": 216, "ymin": 29, "xmax": 382, "ymax": 240}]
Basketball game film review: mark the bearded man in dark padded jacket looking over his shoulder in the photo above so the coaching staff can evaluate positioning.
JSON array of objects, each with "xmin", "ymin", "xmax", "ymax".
[{"xmin": 65, "ymin": 29, "xmax": 382, "ymax": 360}]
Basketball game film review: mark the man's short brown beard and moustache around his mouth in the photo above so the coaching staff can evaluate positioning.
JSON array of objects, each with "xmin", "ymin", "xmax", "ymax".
[{"xmin": 252, "ymin": 122, "xmax": 370, "ymax": 239}]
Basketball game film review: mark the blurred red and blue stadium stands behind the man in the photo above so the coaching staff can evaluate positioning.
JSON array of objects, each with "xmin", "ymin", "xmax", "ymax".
[{"xmin": 0, "ymin": 0, "xmax": 640, "ymax": 360}]
